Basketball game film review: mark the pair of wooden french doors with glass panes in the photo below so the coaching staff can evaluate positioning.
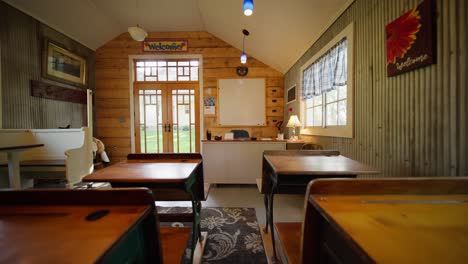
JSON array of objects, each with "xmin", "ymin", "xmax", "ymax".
[{"xmin": 134, "ymin": 82, "xmax": 200, "ymax": 153}]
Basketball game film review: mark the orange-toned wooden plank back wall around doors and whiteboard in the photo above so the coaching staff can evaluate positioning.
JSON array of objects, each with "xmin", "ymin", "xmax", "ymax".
[{"xmin": 95, "ymin": 32, "xmax": 284, "ymax": 161}]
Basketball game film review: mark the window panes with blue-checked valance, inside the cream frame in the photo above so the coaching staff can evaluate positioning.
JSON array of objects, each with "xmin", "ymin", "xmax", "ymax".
[{"xmin": 302, "ymin": 38, "xmax": 348, "ymax": 127}]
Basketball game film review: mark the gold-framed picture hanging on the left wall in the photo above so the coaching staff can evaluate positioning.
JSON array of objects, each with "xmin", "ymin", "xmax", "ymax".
[{"xmin": 42, "ymin": 40, "xmax": 87, "ymax": 87}]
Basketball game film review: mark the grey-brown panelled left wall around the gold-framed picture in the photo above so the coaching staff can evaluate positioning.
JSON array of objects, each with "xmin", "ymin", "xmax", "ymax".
[{"xmin": 0, "ymin": 1, "xmax": 94, "ymax": 128}]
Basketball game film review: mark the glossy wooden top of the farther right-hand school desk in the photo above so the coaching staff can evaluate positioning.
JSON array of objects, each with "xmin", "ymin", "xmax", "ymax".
[{"xmin": 264, "ymin": 154, "xmax": 380, "ymax": 175}]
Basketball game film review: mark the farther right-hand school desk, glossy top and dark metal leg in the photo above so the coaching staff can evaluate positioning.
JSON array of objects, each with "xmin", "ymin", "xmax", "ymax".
[{"xmin": 259, "ymin": 150, "xmax": 379, "ymax": 261}]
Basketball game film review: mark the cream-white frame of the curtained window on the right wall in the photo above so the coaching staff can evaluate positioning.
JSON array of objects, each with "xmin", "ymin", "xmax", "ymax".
[{"xmin": 300, "ymin": 23, "xmax": 354, "ymax": 138}]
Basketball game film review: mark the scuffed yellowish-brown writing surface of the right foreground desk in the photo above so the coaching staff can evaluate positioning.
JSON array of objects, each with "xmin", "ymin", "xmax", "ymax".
[{"xmin": 309, "ymin": 195, "xmax": 468, "ymax": 263}]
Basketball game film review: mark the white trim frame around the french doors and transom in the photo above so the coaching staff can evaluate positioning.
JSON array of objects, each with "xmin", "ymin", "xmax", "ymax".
[{"xmin": 128, "ymin": 54, "xmax": 204, "ymax": 153}]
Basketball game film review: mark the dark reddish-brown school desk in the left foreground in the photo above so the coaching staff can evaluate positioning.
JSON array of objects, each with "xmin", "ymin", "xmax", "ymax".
[{"xmin": 0, "ymin": 188, "xmax": 162, "ymax": 264}]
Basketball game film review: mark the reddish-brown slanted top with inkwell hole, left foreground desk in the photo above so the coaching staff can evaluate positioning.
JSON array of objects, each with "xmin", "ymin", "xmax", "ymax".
[{"xmin": 0, "ymin": 205, "xmax": 150, "ymax": 263}]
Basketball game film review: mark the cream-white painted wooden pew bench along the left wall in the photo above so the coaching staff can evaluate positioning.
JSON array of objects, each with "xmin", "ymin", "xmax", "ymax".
[{"xmin": 0, "ymin": 127, "xmax": 93, "ymax": 188}]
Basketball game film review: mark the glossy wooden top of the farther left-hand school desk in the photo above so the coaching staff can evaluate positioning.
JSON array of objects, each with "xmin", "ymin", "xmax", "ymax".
[{"xmin": 83, "ymin": 159, "xmax": 202, "ymax": 183}]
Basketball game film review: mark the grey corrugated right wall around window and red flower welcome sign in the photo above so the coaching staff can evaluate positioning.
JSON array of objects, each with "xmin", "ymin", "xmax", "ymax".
[{"xmin": 285, "ymin": 0, "xmax": 468, "ymax": 176}]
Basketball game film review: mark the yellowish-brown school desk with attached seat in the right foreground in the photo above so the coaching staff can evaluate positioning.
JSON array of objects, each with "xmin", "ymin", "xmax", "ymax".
[{"xmin": 275, "ymin": 177, "xmax": 468, "ymax": 263}]
